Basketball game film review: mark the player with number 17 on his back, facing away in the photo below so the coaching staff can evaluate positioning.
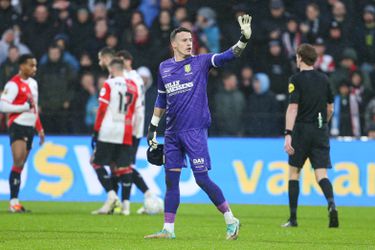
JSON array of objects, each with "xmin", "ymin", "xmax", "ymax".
[{"xmin": 92, "ymin": 58, "xmax": 140, "ymax": 214}]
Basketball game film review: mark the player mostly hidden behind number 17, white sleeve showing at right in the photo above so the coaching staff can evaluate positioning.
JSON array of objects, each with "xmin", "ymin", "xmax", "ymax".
[{"xmin": 116, "ymin": 50, "xmax": 153, "ymax": 215}]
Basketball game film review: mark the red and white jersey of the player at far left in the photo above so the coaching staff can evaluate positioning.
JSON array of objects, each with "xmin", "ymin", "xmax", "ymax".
[{"xmin": 1, "ymin": 75, "xmax": 38, "ymax": 127}]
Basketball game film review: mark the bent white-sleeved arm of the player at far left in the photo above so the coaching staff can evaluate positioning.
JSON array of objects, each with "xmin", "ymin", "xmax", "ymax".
[{"xmin": 0, "ymin": 82, "xmax": 31, "ymax": 113}]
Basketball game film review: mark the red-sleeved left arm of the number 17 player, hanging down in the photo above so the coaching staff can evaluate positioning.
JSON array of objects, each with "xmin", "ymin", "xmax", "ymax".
[{"xmin": 91, "ymin": 82, "xmax": 111, "ymax": 148}]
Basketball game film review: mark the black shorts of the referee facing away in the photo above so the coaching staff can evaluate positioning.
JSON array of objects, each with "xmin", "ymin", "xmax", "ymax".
[{"xmin": 289, "ymin": 123, "xmax": 332, "ymax": 169}]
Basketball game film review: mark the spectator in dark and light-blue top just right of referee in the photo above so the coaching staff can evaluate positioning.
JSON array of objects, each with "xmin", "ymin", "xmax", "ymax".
[{"xmin": 331, "ymin": 80, "xmax": 361, "ymax": 136}]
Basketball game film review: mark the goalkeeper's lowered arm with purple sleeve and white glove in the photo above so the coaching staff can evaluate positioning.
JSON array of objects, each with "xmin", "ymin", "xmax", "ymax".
[{"xmin": 147, "ymin": 70, "xmax": 167, "ymax": 148}]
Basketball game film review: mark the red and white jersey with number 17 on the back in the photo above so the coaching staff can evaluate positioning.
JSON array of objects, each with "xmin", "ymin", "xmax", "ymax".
[{"xmin": 95, "ymin": 77, "xmax": 141, "ymax": 145}]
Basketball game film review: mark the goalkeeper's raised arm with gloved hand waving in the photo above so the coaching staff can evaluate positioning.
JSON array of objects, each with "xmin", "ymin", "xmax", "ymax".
[{"xmin": 211, "ymin": 15, "xmax": 251, "ymax": 67}]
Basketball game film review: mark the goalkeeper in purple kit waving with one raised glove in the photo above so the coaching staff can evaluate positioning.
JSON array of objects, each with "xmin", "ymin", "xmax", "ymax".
[{"xmin": 145, "ymin": 15, "xmax": 251, "ymax": 240}]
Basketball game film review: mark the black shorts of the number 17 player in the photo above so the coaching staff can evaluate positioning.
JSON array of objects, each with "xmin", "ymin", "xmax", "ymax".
[{"xmin": 93, "ymin": 141, "xmax": 132, "ymax": 167}]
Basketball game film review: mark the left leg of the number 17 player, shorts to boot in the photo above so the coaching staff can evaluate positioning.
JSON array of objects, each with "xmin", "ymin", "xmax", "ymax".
[{"xmin": 92, "ymin": 141, "xmax": 119, "ymax": 214}]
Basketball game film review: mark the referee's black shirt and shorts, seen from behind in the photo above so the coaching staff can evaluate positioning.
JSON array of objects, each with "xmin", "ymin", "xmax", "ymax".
[{"xmin": 289, "ymin": 70, "xmax": 333, "ymax": 169}]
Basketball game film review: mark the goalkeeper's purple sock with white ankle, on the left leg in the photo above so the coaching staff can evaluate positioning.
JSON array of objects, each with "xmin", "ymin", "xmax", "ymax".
[{"xmin": 164, "ymin": 170, "xmax": 181, "ymax": 228}]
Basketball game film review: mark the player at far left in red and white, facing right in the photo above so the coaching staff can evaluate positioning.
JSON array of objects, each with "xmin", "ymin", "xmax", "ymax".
[{"xmin": 0, "ymin": 54, "xmax": 44, "ymax": 213}]
